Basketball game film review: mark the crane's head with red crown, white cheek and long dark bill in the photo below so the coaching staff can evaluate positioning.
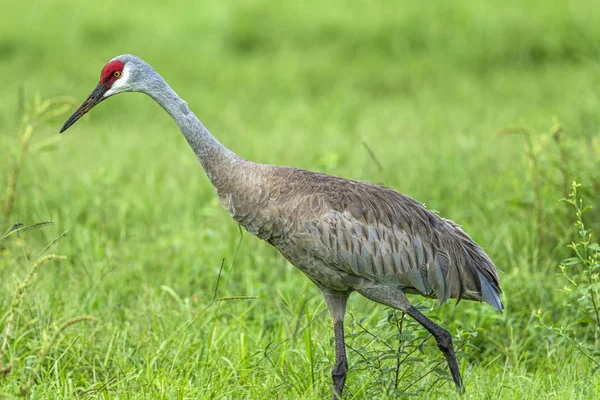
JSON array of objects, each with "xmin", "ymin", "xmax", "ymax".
[{"xmin": 60, "ymin": 54, "xmax": 153, "ymax": 133}]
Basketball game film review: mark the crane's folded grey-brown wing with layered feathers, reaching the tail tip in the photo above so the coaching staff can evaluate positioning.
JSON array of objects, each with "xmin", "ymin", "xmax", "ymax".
[{"xmin": 290, "ymin": 180, "xmax": 502, "ymax": 311}]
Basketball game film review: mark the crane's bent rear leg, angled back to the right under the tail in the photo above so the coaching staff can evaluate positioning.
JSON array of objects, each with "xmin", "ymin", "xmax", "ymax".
[{"xmin": 358, "ymin": 286, "xmax": 465, "ymax": 393}]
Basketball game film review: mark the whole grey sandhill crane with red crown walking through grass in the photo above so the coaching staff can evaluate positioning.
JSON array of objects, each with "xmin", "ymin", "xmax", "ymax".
[{"xmin": 60, "ymin": 54, "xmax": 503, "ymax": 400}]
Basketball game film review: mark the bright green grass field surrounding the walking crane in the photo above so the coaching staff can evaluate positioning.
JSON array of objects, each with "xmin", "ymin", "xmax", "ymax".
[{"xmin": 0, "ymin": 0, "xmax": 600, "ymax": 400}]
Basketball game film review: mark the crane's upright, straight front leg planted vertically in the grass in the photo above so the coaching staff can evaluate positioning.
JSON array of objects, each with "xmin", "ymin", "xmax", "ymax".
[{"xmin": 321, "ymin": 288, "xmax": 351, "ymax": 400}]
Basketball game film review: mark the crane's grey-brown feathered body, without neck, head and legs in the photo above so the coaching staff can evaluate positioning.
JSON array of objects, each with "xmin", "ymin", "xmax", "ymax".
[{"xmin": 214, "ymin": 160, "xmax": 502, "ymax": 311}]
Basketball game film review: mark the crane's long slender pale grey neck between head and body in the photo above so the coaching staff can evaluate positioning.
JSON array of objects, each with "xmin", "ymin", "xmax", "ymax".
[{"xmin": 145, "ymin": 72, "xmax": 243, "ymax": 191}]
